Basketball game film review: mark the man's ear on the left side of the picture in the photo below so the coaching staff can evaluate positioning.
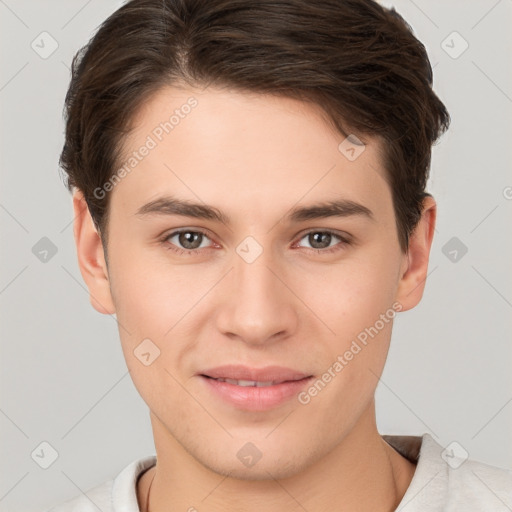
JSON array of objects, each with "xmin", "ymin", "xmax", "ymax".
[{"xmin": 73, "ymin": 190, "xmax": 115, "ymax": 315}]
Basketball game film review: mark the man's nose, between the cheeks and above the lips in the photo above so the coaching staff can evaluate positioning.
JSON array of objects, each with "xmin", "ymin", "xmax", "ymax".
[{"xmin": 217, "ymin": 242, "xmax": 300, "ymax": 346}]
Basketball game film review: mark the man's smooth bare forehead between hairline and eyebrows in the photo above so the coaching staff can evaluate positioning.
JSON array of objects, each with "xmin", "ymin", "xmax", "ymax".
[{"xmin": 112, "ymin": 87, "xmax": 391, "ymax": 224}]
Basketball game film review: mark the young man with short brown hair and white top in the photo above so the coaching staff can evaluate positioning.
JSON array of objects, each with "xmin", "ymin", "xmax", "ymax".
[{"xmin": 46, "ymin": 0, "xmax": 512, "ymax": 512}]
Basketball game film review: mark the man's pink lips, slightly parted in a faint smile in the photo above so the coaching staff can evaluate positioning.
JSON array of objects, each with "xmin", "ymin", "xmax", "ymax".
[{"xmin": 197, "ymin": 365, "xmax": 313, "ymax": 411}]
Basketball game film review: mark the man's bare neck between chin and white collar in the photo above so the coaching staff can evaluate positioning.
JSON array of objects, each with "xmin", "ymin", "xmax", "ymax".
[{"xmin": 137, "ymin": 407, "xmax": 415, "ymax": 512}]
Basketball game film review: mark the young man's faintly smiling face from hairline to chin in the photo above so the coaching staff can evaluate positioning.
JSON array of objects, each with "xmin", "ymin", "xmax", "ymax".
[{"xmin": 75, "ymin": 83, "xmax": 433, "ymax": 479}]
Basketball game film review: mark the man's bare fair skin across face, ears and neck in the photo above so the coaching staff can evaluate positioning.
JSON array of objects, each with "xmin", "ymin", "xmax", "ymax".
[{"xmin": 73, "ymin": 87, "xmax": 436, "ymax": 512}]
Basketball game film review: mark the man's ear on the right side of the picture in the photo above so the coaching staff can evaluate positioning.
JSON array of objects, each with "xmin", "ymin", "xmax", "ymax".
[{"xmin": 397, "ymin": 196, "xmax": 437, "ymax": 311}]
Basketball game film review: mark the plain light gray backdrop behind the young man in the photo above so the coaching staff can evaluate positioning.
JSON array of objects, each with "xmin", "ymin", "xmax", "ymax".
[{"xmin": 0, "ymin": 0, "xmax": 512, "ymax": 512}]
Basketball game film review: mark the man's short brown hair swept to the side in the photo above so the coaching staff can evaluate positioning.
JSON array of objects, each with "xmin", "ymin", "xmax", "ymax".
[{"xmin": 60, "ymin": 0, "xmax": 450, "ymax": 252}]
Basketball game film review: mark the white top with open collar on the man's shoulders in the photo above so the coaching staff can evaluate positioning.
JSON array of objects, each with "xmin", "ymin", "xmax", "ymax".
[{"xmin": 46, "ymin": 434, "xmax": 512, "ymax": 512}]
